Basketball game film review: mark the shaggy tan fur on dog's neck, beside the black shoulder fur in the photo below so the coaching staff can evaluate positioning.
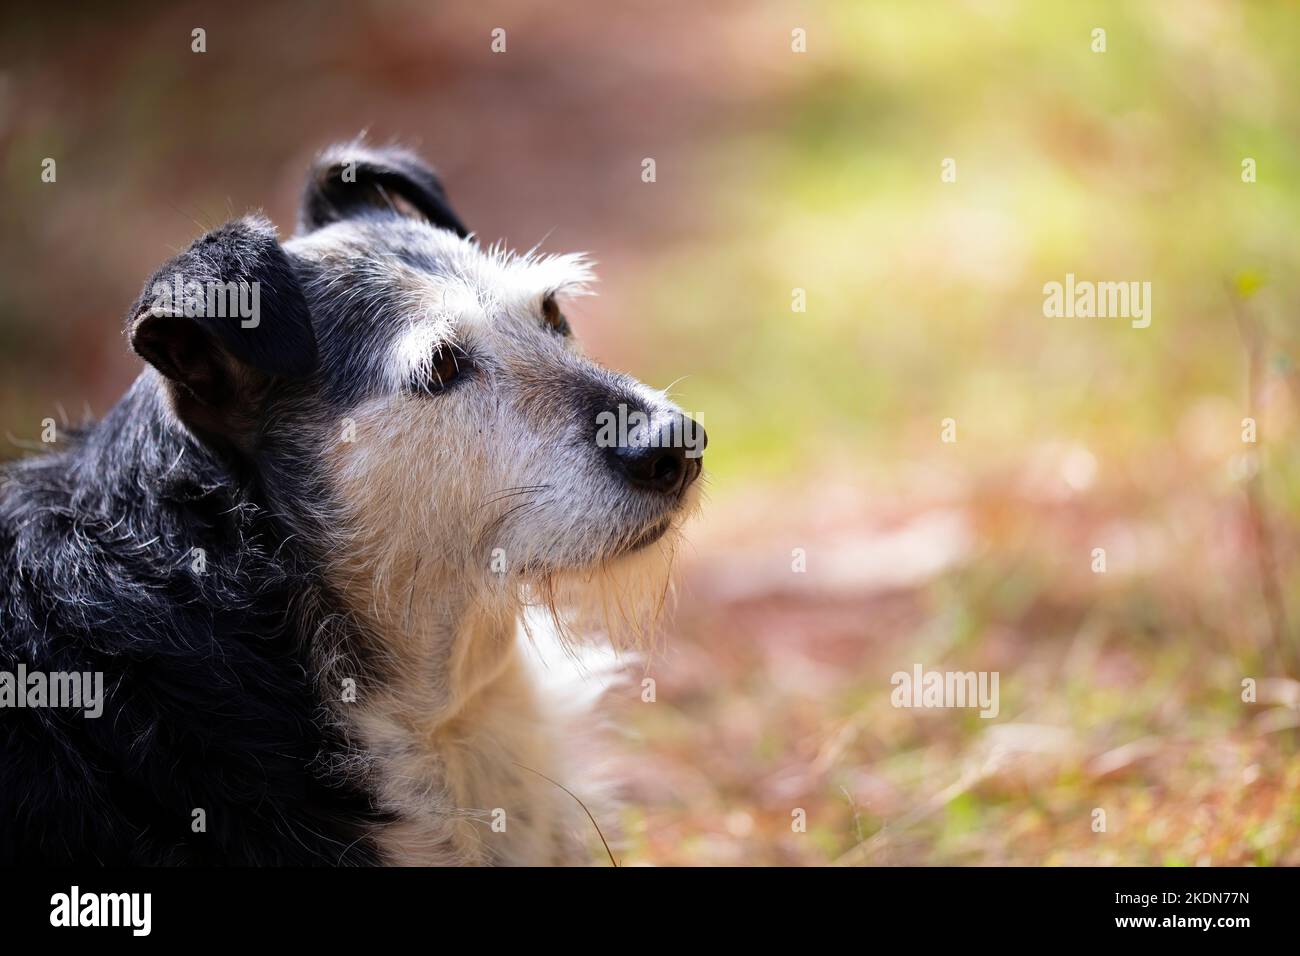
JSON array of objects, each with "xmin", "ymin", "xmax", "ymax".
[{"xmin": 325, "ymin": 549, "xmax": 595, "ymax": 865}]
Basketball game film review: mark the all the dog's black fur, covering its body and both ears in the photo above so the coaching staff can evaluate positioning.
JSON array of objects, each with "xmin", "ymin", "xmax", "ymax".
[{"xmin": 0, "ymin": 141, "xmax": 464, "ymax": 865}]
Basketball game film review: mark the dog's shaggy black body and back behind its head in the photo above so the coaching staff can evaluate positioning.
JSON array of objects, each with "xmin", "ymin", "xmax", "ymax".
[{"xmin": 0, "ymin": 376, "xmax": 372, "ymax": 865}]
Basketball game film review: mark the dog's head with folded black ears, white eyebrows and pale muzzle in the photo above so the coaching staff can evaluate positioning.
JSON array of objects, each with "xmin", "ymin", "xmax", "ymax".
[{"xmin": 129, "ymin": 144, "xmax": 705, "ymax": 639}]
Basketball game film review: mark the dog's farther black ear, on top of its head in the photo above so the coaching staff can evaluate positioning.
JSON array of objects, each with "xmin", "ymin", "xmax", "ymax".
[{"xmin": 298, "ymin": 143, "xmax": 469, "ymax": 237}]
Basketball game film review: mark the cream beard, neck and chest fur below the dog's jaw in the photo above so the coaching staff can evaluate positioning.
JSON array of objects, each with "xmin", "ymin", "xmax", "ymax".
[{"xmin": 330, "ymin": 492, "xmax": 694, "ymax": 865}]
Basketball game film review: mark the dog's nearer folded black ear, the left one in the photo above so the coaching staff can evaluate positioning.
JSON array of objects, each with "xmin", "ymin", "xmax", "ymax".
[{"xmin": 127, "ymin": 216, "xmax": 317, "ymax": 429}]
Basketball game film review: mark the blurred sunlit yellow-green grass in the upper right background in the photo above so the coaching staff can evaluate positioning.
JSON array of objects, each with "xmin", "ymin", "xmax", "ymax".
[{"xmin": 645, "ymin": 4, "xmax": 1300, "ymax": 480}]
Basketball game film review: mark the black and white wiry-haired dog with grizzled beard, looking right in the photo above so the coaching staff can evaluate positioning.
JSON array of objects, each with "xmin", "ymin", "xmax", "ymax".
[{"xmin": 0, "ymin": 142, "xmax": 707, "ymax": 865}]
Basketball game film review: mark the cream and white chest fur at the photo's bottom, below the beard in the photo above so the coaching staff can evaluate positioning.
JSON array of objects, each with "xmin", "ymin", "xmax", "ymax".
[{"xmin": 351, "ymin": 613, "xmax": 610, "ymax": 866}]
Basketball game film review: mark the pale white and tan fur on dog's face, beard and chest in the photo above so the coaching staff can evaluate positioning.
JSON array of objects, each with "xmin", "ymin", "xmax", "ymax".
[{"xmin": 289, "ymin": 224, "xmax": 694, "ymax": 862}]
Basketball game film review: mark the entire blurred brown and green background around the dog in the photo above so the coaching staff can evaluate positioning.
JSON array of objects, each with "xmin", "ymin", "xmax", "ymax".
[{"xmin": 0, "ymin": 0, "xmax": 1300, "ymax": 864}]
